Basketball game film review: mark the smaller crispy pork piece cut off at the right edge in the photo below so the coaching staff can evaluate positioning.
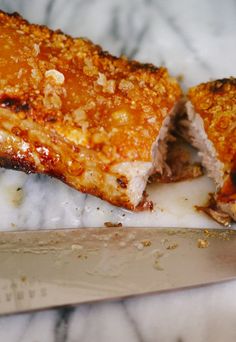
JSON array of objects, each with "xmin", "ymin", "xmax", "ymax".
[{"xmin": 182, "ymin": 78, "xmax": 236, "ymax": 220}]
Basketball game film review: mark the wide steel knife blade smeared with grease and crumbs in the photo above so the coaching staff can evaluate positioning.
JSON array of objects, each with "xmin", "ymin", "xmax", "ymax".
[{"xmin": 0, "ymin": 227, "xmax": 236, "ymax": 314}]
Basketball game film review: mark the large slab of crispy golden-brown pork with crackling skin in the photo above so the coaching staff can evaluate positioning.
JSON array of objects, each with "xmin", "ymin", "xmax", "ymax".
[{"xmin": 0, "ymin": 12, "xmax": 181, "ymax": 209}]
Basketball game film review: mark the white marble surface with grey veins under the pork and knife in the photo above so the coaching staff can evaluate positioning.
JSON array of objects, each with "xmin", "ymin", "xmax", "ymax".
[{"xmin": 0, "ymin": 0, "xmax": 236, "ymax": 342}]
